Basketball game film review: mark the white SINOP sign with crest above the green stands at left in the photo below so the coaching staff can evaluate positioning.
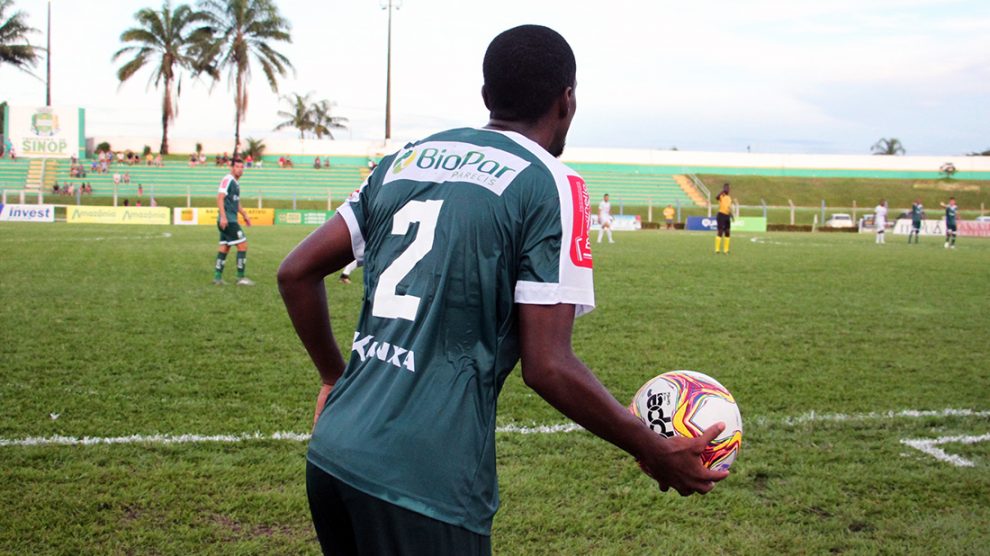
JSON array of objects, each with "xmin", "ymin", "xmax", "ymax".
[{"xmin": 7, "ymin": 106, "xmax": 83, "ymax": 158}]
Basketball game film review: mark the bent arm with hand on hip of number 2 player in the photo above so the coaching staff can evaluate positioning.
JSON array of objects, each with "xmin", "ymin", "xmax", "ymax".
[{"xmin": 278, "ymin": 215, "xmax": 354, "ymax": 424}]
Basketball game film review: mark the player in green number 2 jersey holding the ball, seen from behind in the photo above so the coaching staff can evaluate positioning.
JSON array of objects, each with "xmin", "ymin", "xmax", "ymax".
[{"xmin": 278, "ymin": 25, "xmax": 728, "ymax": 555}]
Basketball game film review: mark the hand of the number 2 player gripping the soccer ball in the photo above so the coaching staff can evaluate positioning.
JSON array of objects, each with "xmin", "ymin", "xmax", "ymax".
[{"xmin": 639, "ymin": 423, "xmax": 729, "ymax": 496}]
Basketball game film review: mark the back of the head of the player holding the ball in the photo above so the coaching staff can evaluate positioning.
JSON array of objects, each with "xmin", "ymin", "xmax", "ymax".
[{"xmin": 482, "ymin": 25, "xmax": 577, "ymax": 122}]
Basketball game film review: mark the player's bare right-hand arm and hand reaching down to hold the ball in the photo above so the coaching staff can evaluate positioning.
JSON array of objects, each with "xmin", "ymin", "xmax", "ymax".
[{"xmin": 518, "ymin": 304, "xmax": 728, "ymax": 496}]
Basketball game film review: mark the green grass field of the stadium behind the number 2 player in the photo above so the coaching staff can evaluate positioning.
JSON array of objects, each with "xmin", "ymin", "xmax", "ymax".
[{"xmin": 0, "ymin": 224, "xmax": 990, "ymax": 555}]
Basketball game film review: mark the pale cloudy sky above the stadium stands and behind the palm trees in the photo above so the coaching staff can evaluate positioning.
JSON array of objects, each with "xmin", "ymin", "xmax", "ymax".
[{"xmin": 0, "ymin": 0, "xmax": 990, "ymax": 155}]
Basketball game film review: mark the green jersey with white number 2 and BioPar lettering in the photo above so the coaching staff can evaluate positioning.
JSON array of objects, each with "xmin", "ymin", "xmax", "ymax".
[{"xmin": 308, "ymin": 129, "xmax": 594, "ymax": 535}]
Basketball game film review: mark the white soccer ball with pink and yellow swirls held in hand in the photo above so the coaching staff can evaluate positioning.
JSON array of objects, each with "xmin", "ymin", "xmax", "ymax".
[{"xmin": 629, "ymin": 371, "xmax": 742, "ymax": 471}]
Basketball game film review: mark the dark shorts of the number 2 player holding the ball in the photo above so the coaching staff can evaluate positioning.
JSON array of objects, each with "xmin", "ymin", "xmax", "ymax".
[{"xmin": 306, "ymin": 461, "xmax": 492, "ymax": 556}]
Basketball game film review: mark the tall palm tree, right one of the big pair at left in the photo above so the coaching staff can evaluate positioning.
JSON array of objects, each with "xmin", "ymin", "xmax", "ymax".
[{"xmin": 199, "ymin": 0, "xmax": 292, "ymax": 153}]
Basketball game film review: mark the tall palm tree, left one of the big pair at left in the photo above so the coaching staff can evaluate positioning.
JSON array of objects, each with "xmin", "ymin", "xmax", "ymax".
[{"xmin": 113, "ymin": 0, "xmax": 209, "ymax": 154}]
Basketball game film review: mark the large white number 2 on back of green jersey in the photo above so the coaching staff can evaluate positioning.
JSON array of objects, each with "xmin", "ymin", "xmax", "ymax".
[{"xmin": 371, "ymin": 201, "xmax": 443, "ymax": 320}]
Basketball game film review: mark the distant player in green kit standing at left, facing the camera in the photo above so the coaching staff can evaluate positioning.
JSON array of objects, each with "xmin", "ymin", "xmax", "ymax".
[{"xmin": 213, "ymin": 157, "xmax": 254, "ymax": 286}]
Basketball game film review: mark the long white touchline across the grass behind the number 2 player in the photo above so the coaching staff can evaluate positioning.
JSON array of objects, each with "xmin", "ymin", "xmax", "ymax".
[{"xmin": 0, "ymin": 408, "xmax": 990, "ymax": 453}]
